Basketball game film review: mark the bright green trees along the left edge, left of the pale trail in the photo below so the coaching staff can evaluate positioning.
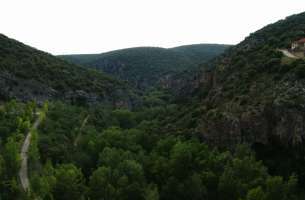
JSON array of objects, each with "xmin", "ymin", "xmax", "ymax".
[{"xmin": 0, "ymin": 101, "xmax": 35, "ymax": 199}]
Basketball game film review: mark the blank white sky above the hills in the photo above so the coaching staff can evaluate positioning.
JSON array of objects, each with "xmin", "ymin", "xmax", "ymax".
[{"xmin": 0, "ymin": 0, "xmax": 305, "ymax": 55}]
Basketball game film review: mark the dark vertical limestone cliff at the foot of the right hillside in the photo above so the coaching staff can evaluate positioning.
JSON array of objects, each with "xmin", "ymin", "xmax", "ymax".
[{"xmin": 199, "ymin": 103, "xmax": 305, "ymax": 146}]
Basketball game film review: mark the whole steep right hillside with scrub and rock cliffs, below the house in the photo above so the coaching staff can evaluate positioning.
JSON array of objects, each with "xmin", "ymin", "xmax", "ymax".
[{"xmin": 180, "ymin": 10, "xmax": 305, "ymax": 194}]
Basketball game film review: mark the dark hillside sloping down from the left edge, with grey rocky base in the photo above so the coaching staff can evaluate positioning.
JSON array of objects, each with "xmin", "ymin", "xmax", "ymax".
[{"xmin": 0, "ymin": 34, "xmax": 135, "ymax": 104}]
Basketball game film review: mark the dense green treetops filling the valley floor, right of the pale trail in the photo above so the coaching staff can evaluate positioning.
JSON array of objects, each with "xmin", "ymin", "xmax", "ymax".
[{"xmin": 5, "ymin": 102, "xmax": 297, "ymax": 200}]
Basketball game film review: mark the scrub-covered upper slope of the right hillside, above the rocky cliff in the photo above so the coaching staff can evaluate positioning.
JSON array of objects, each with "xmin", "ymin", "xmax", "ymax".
[{"xmin": 202, "ymin": 13, "xmax": 305, "ymax": 110}]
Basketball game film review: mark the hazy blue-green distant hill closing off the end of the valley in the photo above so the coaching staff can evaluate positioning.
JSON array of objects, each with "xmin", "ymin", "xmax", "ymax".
[{"xmin": 59, "ymin": 44, "xmax": 229, "ymax": 89}]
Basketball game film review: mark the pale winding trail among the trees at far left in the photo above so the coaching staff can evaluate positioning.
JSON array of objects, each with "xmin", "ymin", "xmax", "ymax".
[{"xmin": 19, "ymin": 113, "xmax": 42, "ymax": 192}]
